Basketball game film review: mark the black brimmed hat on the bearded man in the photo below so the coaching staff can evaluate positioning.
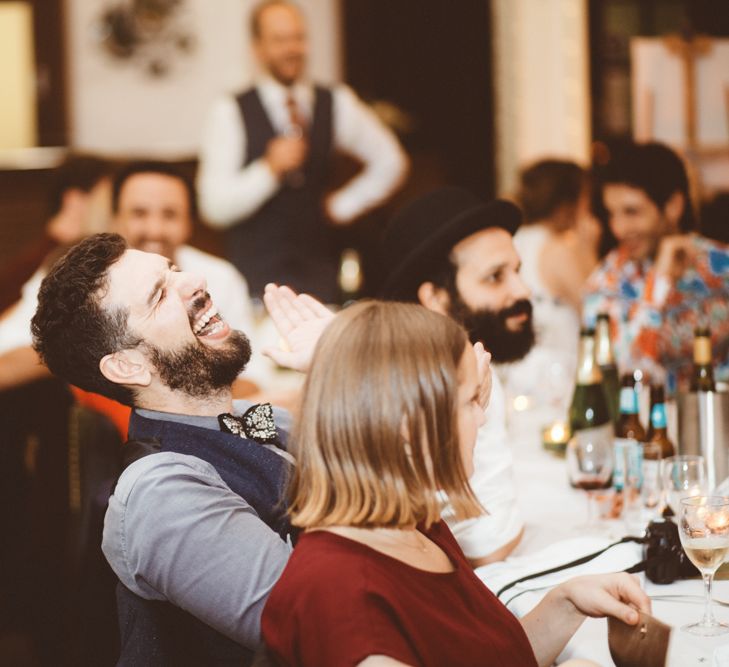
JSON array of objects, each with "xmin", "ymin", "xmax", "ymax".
[{"xmin": 381, "ymin": 187, "xmax": 521, "ymax": 301}]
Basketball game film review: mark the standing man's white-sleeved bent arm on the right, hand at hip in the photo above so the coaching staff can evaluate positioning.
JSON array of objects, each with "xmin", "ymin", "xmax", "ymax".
[{"xmin": 329, "ymin": 86, "xmax": 408, "ymax": 222}]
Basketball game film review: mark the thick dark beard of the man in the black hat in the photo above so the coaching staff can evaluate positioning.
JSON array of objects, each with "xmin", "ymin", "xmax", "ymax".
[{"xmin": 450, "ymin": 294, "xmax": 534, "ymax": 364}]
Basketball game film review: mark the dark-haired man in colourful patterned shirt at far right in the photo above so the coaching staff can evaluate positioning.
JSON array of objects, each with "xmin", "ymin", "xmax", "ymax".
[{"xmin": 584, "ymin": 143, "xmax": 729, "ymax": 391}]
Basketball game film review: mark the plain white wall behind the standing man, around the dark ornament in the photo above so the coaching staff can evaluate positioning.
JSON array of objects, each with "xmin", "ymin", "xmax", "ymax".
[{"xmin": 66, "ymin": 0, "xmax": 341, "ymax": 157}]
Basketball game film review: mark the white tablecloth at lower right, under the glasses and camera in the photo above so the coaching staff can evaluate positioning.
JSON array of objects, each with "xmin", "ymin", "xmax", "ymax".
[{"xmin": 484, "ymin": 408, "xmax": 729, "ymax": 667}]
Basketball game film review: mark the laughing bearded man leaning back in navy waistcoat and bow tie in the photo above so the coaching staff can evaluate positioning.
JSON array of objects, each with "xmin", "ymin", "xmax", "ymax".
[{"xmin": 32, "ymin": 234, "xmax": 332, "ymax": 667}]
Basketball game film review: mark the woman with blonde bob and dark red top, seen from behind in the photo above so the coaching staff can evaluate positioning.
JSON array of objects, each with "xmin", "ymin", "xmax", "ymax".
[{"xmin": 262, "ymin": 300, "xmax": 650, "ymax": 667}]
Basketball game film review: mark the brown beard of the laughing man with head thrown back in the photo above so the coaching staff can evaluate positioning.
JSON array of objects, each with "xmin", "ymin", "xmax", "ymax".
[{"xmin": 147, "ymin": 331, "xmax": 251, "ymax": 398}]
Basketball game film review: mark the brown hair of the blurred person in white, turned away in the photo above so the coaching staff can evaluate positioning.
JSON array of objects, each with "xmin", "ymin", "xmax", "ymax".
[{"xmin": 516, "ymin": 160, "xmax": 587, "ymax": 223}]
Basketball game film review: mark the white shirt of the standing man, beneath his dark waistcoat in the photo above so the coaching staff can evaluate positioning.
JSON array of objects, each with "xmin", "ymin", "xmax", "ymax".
[{"xmin": 198, "ymin": 77, "xmax": 408, "ymax": 228}]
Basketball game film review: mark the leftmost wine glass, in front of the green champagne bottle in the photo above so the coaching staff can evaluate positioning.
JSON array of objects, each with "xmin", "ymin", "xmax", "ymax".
[{"xmin": 566, "ymin": 431, "xmax": 613, "ymax": 529}]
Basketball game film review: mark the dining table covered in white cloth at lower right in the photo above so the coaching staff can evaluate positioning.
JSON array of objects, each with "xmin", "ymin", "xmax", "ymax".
[{"xmin": 477, "ymin": 402, "xmax": 729, "ymax": 667}]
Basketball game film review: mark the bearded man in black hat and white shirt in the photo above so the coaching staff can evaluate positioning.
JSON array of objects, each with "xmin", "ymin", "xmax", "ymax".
[{"xmin": 381, "ymin": 187, "xmax": 534, "ymax": 566}]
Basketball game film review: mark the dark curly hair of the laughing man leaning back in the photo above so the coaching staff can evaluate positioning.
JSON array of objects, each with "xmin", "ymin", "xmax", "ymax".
[{"xmin": 31, "ymin": 234, "xmax": 141, "ymax": 405}]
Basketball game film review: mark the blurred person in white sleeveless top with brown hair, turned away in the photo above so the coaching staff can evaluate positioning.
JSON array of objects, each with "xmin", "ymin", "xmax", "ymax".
[{"xmin": 503, "ymin": 159, "xmax": 600, "ymax": 418}]
